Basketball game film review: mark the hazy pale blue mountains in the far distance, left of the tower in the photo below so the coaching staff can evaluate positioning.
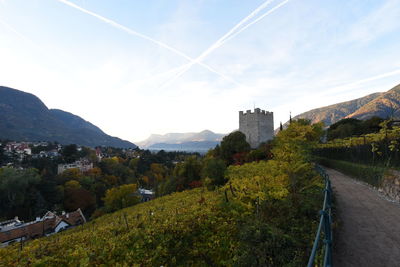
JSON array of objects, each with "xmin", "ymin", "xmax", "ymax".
[{"xmin": 137, "ymin": 130, "xmax": 225, "ymax": 152}]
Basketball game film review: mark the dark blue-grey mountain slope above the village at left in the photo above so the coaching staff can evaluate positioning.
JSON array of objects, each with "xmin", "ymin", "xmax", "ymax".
[{"xmin": 0, "ymin": 86, "xmax": 136, "ymax": 148}]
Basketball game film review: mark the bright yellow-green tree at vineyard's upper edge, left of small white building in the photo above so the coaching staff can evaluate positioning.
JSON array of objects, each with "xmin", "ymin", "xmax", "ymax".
[{"xmin": 103, "ymin": 184, "xmax": 140, "ymax": 212}]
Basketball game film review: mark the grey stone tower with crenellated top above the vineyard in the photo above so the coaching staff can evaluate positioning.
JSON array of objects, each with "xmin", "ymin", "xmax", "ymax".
[{"xmin": 239, "ymin": 108, "xmax": 274, "ymax": 148}]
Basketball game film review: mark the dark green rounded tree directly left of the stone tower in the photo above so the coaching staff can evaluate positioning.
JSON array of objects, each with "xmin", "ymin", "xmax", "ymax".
[{"xmin": 220, "ymin": 131, "xmax": 250, "ymax": 164}]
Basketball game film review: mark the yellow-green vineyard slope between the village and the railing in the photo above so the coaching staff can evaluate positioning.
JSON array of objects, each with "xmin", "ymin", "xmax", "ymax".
[{"xmin": 0, "ymin": 123, "xmax": 323, "ymax": 266}]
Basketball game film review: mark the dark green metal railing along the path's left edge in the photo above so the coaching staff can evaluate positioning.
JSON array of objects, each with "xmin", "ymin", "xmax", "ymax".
[{"xmin": 307, "ymin": 165, "xmax": 332, "ymax": 267}]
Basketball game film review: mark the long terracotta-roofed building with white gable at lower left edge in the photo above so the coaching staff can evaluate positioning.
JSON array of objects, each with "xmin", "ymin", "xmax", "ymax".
[{"xmin": 0, "ymin": 209, "xmax": 86, "ymax": 247}]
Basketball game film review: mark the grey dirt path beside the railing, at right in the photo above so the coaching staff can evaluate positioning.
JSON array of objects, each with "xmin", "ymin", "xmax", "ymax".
[{"xmin": 327, "ymin": 169, "xmax": 400, "ymax": 267}]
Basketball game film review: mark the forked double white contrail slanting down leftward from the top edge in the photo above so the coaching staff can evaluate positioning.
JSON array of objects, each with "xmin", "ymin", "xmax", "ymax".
[{"xmin": 161, "ymin": 0, "xmax": 289, "ymax": 88}]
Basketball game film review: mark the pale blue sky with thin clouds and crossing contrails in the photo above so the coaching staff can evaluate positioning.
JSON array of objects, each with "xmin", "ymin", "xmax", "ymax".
[{"xmin": 0, "ymin": 0, "xmax": 400, "ymax": 142}]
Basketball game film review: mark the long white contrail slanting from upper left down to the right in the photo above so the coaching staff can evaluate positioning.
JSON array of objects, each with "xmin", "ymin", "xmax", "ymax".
[{"xmin": 57, "ymin": 0, "xmax": 239, "ymax": 87}]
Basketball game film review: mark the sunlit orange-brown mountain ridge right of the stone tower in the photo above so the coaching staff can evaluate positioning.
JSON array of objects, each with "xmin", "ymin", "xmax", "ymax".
[{"xmin": 285, "ymin": 85, "xmax": 400, "ymax": 126}]
